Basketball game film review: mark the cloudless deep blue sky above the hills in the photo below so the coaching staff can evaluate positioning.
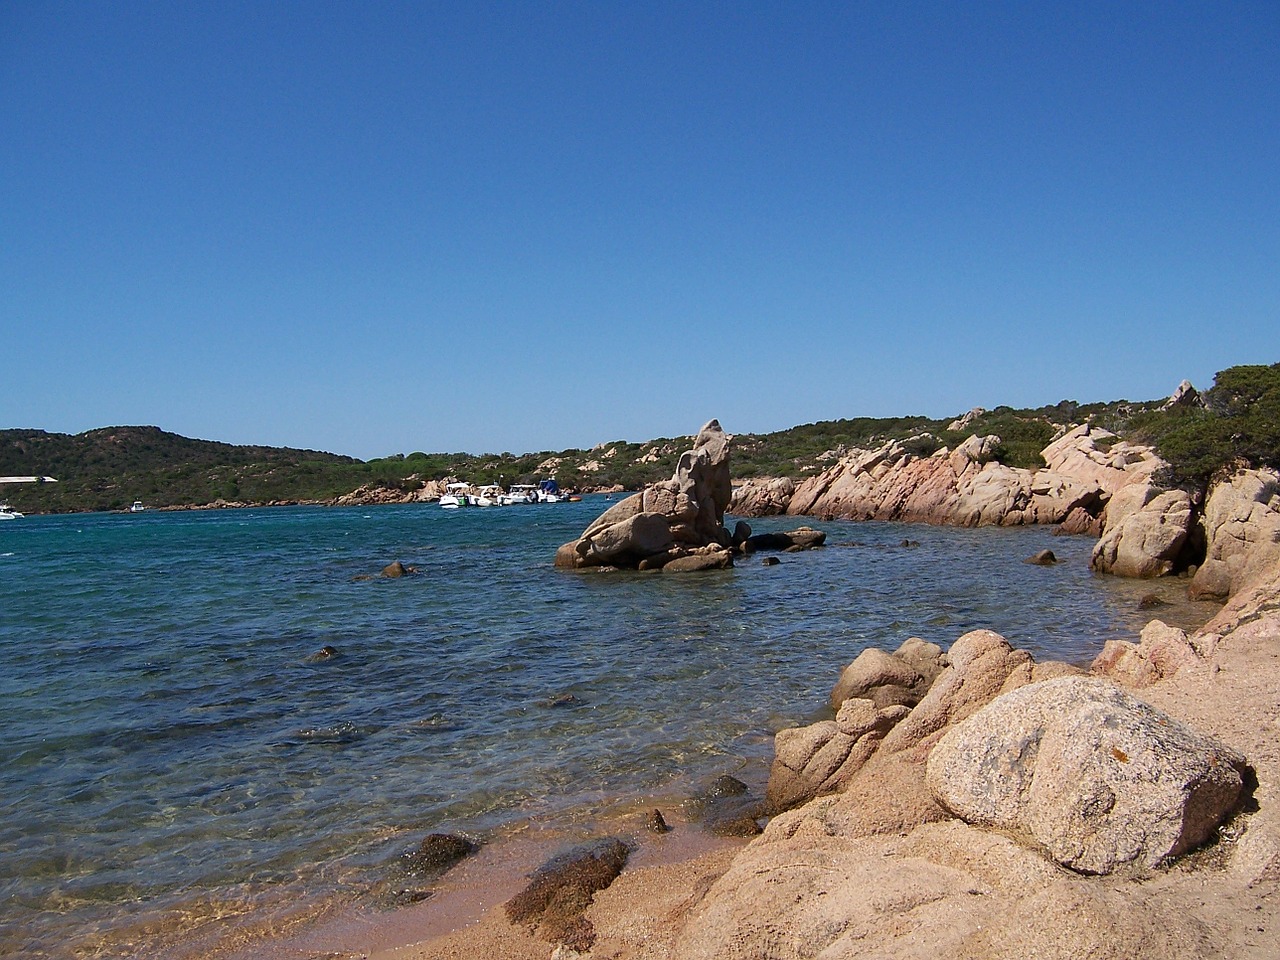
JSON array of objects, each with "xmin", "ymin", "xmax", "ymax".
[{"xmin": 0, "ymin": 0, "xmax": 1280, "ymax": 458}]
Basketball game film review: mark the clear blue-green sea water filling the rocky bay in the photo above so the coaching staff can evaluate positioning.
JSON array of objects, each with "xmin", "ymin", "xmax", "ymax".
[{"xmin": 0, "ymin": 495, "xmax": 1212, "ymax": 957}]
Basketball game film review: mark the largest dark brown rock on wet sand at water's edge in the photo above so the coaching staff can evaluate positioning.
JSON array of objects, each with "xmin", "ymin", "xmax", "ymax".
[{"xmin": 503, "ymin": 837, "xmax": 631, "ymax": 948}]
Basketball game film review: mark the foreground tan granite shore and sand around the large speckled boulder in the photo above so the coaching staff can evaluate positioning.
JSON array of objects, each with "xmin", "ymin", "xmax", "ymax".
[{"xmin": 351, "ymin": 542, "xmax": 1280, "ymax": 960}]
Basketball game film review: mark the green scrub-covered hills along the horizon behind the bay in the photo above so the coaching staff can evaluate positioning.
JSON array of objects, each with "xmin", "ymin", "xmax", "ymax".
[{"xmin": 0, "ymin": 364, "xmax": 1280, "ymax": 513}]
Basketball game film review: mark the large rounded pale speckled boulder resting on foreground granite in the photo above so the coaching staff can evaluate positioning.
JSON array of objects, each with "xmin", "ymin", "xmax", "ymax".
[{"xmin": 927, "ymin": 677, "xmax": 1247, "ymax": 874}]
